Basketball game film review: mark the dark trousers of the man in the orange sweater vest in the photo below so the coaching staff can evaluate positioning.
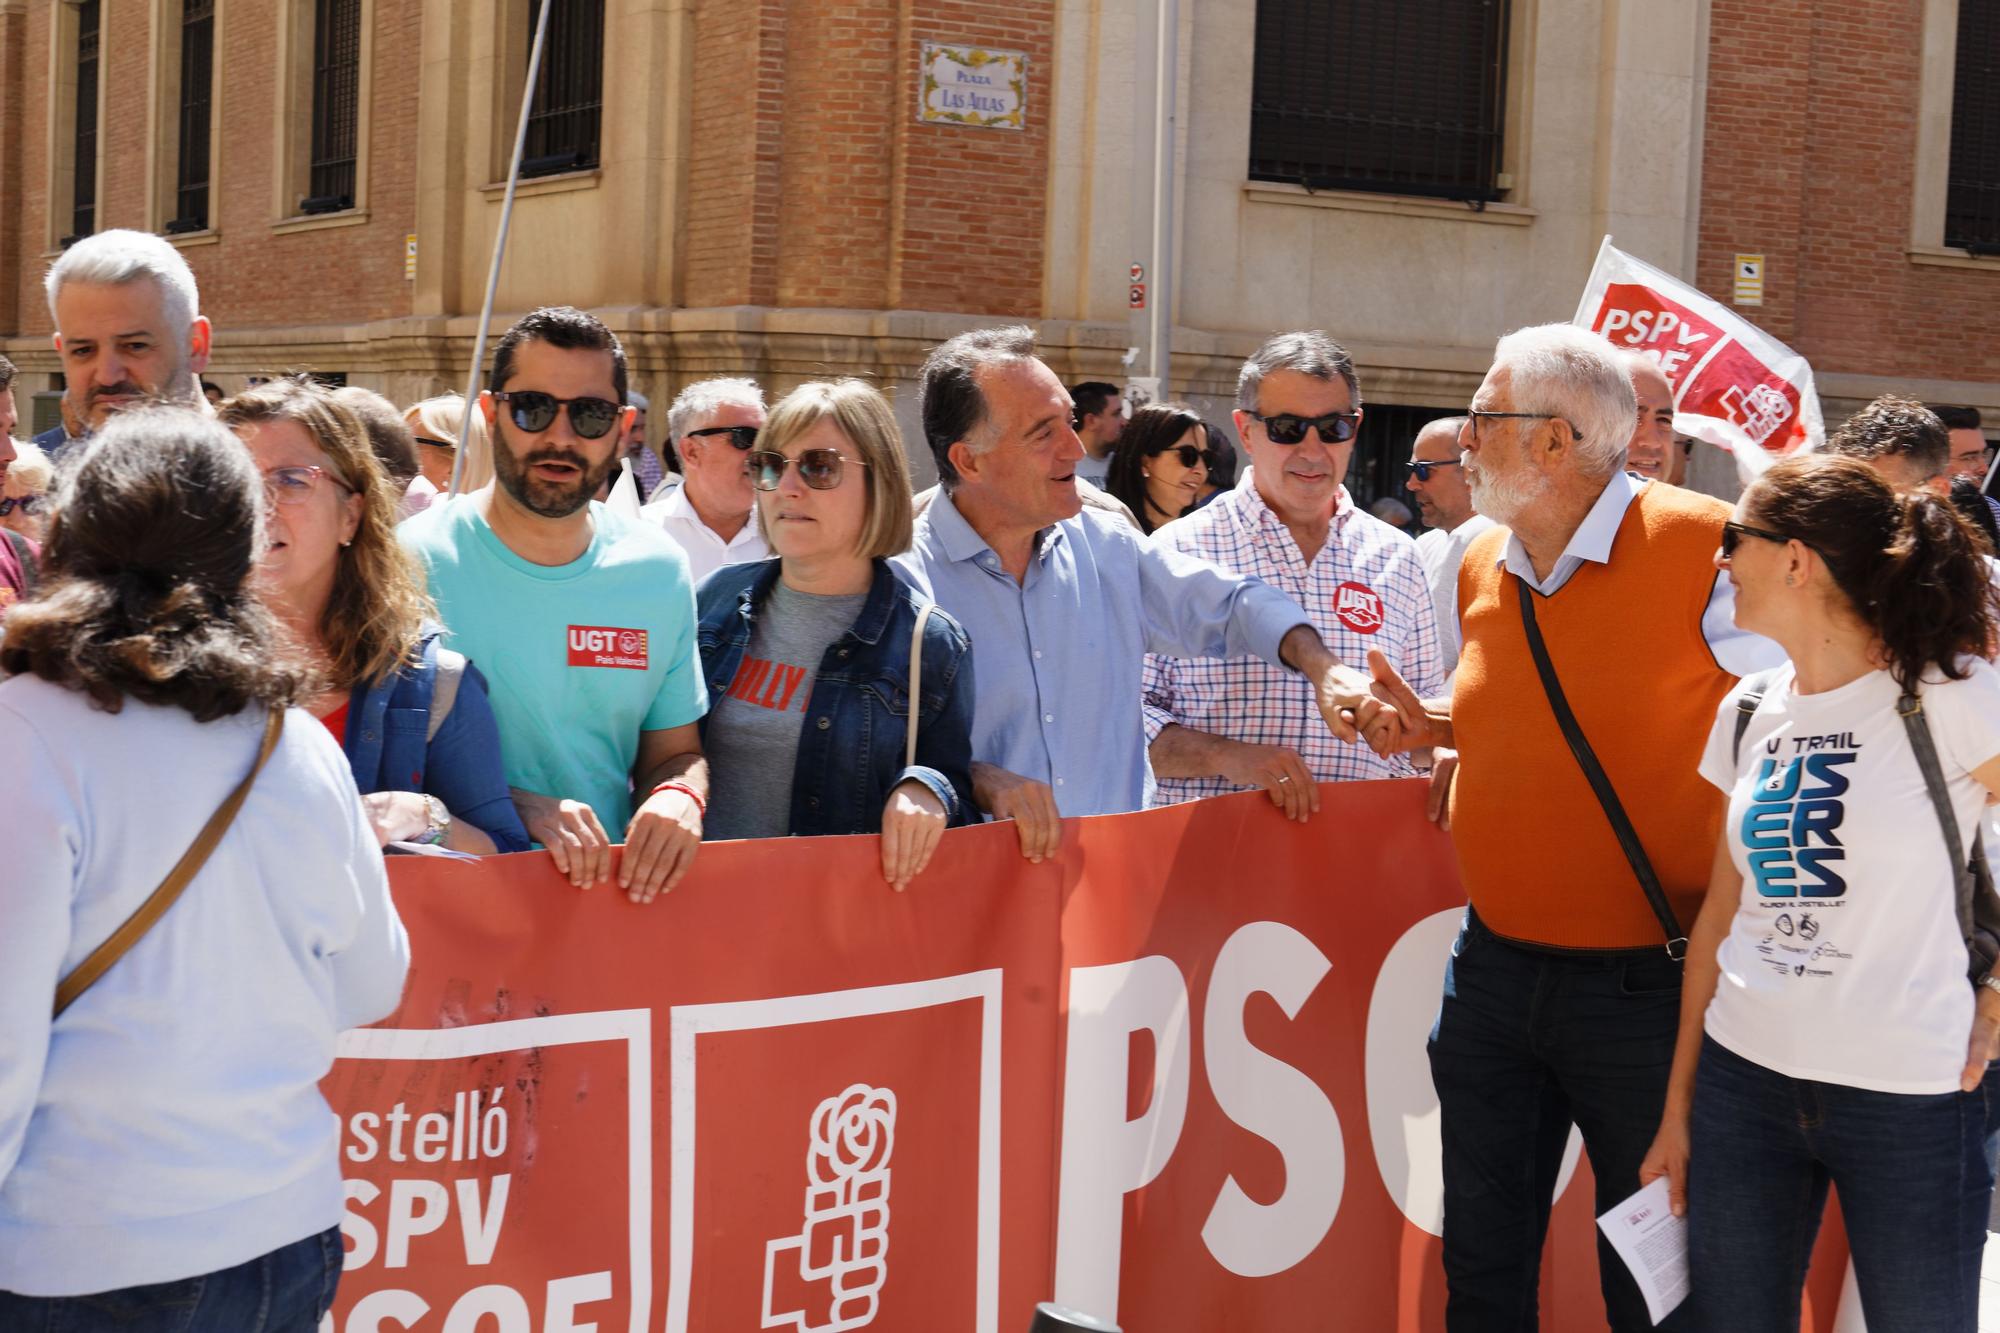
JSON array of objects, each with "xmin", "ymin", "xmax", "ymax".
[{"xmin": 1430, "ymin": 908, "xmax": 1696, "ymax": 1333}]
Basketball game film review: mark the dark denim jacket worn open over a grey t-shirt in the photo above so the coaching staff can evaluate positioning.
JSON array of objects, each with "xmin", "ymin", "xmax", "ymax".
[{"xmin": 694, "ymin": 558, "xmax": 976, "ymax": 837}]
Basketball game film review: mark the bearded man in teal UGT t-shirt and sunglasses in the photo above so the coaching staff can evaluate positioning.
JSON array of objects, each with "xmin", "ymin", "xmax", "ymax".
[{"xmin": 400, "ymin": 306, "xmax": 708, "ymax": 901}]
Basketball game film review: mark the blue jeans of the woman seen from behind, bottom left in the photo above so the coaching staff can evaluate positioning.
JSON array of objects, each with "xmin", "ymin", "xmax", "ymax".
[{"xmin": 0, "ymin": 1227, "xmax": 342, "ymax": 1333}]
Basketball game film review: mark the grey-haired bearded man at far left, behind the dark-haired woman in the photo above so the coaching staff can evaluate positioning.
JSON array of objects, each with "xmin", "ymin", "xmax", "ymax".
[{"xmin": 34, "ymin": 230, "xmax": 210, "ymax": 458}]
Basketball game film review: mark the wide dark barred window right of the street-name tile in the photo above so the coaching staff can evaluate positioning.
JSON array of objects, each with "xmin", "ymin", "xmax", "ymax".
[{"xmin": 1250, "ymin": 0, "xmax": 1508, "ymax": 202}]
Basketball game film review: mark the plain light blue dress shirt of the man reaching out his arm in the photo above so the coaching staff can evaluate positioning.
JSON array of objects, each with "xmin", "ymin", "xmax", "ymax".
[{"xmin": 896, "ymin": 490, "xmax": 1310, "ymax": 817}]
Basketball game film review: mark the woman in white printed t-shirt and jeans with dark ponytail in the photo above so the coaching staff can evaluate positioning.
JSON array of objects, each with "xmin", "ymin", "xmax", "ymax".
[{"xmin": 1640, "ymin": 456, "xmax": 2000, "ymax": 1333}]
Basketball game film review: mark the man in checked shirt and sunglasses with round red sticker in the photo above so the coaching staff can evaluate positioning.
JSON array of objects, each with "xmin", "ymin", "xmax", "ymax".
[{"xmin": 1142, "ymin": 330, "xmax": 1444, "ymax": 821}]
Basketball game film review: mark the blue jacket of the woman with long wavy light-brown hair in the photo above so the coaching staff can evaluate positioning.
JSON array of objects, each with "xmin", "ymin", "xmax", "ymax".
[{"xmin": 340, "ymin": 624, "xmax": 528, "ymax": 853}]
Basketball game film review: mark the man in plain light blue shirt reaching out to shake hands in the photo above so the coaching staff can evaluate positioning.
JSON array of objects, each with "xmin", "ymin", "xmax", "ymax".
[{"xmin": 898, "ymin": 326, "xmax": 1380, "ymax": 861}]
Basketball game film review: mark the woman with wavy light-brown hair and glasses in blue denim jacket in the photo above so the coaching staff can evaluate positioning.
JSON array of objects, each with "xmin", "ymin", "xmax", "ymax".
[{"xmin": 220, "ymin": 378, "xmax": 528, "ymax": 855}]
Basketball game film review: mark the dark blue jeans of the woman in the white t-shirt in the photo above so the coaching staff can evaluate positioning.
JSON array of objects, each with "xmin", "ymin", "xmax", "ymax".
[{"xmin": 1688, "ymin": 1037, "xmax": 1992, "ymax": 1333}]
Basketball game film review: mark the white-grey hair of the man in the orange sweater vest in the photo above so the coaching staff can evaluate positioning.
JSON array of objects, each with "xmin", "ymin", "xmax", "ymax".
[{"xmin": 1494, "ymin": 324, "xmax": 1638, "ymax": 476}]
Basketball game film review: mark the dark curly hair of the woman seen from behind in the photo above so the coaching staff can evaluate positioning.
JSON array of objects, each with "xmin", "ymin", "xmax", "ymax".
[{"xmin": 0, "ymin": 406, "xmax": 306, "ymax": 723}]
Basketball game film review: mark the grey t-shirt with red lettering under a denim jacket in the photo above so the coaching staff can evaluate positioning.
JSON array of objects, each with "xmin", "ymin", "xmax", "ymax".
[{"xmin": 702, "ymin": 578, "xmax": 868, "ymax": 841}]
